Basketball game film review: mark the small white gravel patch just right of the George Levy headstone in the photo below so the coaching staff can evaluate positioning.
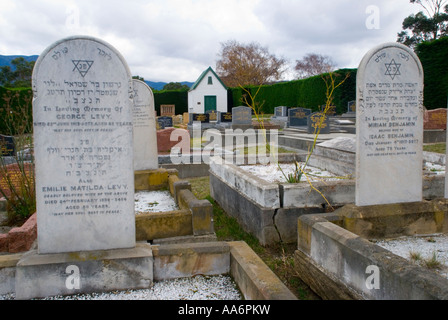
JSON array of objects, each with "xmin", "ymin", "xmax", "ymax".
[{"xmin": 135, "ymin": 191, "xmax": 179, "ymax": 214}]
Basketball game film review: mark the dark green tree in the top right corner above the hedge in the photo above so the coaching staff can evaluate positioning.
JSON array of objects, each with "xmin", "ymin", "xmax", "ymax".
[{"xmin": 397, "ymin": 0, "xmax": 448, "ymax": 48}]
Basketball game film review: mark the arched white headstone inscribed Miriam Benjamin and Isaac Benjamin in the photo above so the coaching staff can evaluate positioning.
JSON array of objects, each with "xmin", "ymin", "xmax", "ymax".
[{"xmin": 356, "ymin": 43, "xmax": 423, "ymax": 206}]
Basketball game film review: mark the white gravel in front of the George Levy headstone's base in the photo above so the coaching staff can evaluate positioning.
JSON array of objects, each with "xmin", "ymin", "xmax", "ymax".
[{"xmin": 0, "ymin": 275, "xmax": 243, "ymax": 300}]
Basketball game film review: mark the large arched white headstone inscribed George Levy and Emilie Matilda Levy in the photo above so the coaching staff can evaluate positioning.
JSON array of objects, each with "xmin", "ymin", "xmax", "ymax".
[{"xmin": 32, "ymin": 37, "xmax": 135, "ymax": 253}]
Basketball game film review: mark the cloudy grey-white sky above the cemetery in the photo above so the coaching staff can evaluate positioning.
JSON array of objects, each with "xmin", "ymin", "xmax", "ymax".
[{"xmin": 0, "ymin": 0, "xmax": 421, "ymax": 82}]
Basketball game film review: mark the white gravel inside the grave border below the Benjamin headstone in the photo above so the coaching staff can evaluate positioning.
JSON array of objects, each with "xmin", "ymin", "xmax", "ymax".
[{"xmin": 372, "ymin": 234, "xmax": 448, "ymax": 278}]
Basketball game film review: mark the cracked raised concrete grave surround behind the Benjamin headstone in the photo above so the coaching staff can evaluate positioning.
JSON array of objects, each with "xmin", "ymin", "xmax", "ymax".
[{"xmin": 210, "ymin": 152, "xmax": 445, "ymax": 245}]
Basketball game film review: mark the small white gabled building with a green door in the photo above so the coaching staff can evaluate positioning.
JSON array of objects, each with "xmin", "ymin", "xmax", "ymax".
[{"xmin": 188, "ymin": 67, "xmax": 227, "ymax": 113}]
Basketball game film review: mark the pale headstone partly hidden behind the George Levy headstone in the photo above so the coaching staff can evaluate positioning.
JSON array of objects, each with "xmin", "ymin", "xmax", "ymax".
[{"xmin": 133, "ymin": 79, "xmax": 159, "ymax": 171}]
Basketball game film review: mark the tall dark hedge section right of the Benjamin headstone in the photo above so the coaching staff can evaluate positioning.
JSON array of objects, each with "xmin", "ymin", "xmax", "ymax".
[{"xmin": 416, "ymin": 37, "xmax": 448, "ymax": 110}]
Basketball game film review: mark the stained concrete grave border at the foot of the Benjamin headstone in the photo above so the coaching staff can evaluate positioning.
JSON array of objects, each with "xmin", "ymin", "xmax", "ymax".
[{"xmin": 294, "ymin": 199, "xmax": 448, "ymax": 300}]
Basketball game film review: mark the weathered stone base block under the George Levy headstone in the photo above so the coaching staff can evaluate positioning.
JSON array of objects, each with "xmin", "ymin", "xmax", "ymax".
[{"xmin": 15, "ymin": 243, "xmax": 153, "ymax": 300}]
